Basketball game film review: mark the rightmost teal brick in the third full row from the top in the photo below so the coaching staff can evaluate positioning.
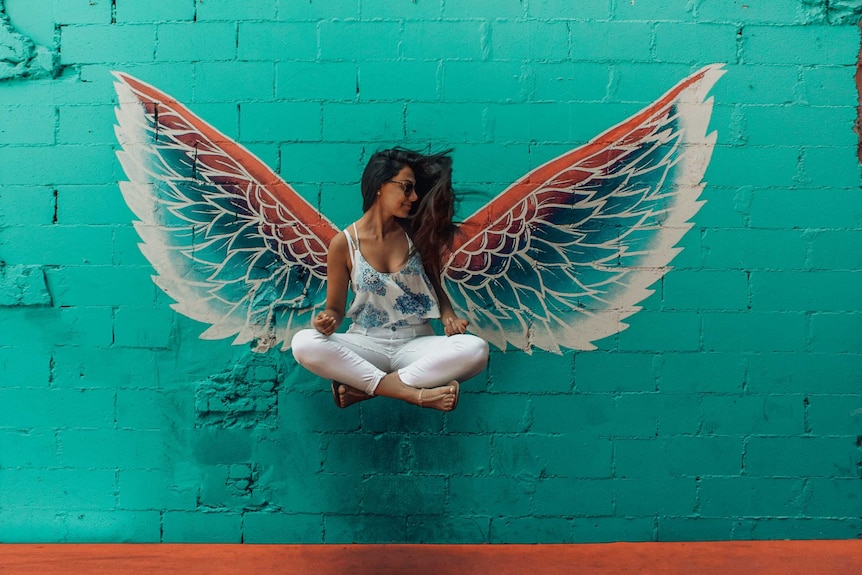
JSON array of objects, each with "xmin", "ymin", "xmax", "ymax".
[{"xmin": 740, "ymin": 102, "xmax": 857, "ymax": 147}]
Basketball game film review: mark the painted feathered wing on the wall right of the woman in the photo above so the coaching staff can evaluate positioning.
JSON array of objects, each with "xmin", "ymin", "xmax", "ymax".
[{"xmin": 444, "ymin": 65, "xmax": 724, "ymax": 353}]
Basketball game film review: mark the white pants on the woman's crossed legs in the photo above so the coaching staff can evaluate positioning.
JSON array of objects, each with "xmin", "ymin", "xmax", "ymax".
[{"xmin": 290, "ymin": 324, "xmax": 488, "ymax": 395}]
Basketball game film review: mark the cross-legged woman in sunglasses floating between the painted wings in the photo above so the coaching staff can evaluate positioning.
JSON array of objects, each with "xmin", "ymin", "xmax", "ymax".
[{"xmin": 291, "ymin": 148, "xmax": 488, "ymax": 411}]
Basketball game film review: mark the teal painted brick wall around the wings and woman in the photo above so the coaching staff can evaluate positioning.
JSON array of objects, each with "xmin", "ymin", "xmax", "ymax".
[{"xmin": 0, "ymin": 0, "xmax": 862, "ymax": 543}]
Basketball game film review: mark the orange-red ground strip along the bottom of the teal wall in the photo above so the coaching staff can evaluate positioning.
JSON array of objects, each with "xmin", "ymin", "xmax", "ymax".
[{"xmin": 0, "ymin": 540, "xmax": 862, "ymax": 575}]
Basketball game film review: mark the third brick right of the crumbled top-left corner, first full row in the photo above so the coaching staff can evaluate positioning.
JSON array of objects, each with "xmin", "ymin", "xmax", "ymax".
[{"xmin": 237, "ymin": 22, "xmax": 318, "ymax": 62}]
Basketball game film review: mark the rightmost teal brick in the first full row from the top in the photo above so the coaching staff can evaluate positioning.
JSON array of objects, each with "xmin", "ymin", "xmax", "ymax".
[{"xmin": 742, "ymin": 25, "xmax": 859, "ymax": 65}]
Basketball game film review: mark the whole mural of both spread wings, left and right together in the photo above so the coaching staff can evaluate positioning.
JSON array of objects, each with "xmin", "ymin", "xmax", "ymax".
[{"xmin": 116, "ymin": 62, "xmax": 723, "ymax": 352}]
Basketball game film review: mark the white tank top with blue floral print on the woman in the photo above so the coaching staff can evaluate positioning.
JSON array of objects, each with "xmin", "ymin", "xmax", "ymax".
[{"xmin": 344, "ymin": 224, "xmax": 440, "ymax": 328}]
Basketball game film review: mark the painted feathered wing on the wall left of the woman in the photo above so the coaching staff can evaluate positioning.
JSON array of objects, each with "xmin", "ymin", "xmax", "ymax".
[{"xmin": 115, "ymin": 73, "xmax": 338, "ymax": 351}]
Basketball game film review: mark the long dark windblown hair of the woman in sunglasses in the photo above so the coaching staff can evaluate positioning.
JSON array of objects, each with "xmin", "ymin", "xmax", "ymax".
[{"xmin": 361, "ymin": 148, "xmax": 457, "ymax": 283}]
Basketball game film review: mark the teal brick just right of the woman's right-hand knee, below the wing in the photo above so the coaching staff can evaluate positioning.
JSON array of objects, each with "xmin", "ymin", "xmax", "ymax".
[{"xmin": 488, "ymin": 351, "xmax": 575, "ymax": 394}]
